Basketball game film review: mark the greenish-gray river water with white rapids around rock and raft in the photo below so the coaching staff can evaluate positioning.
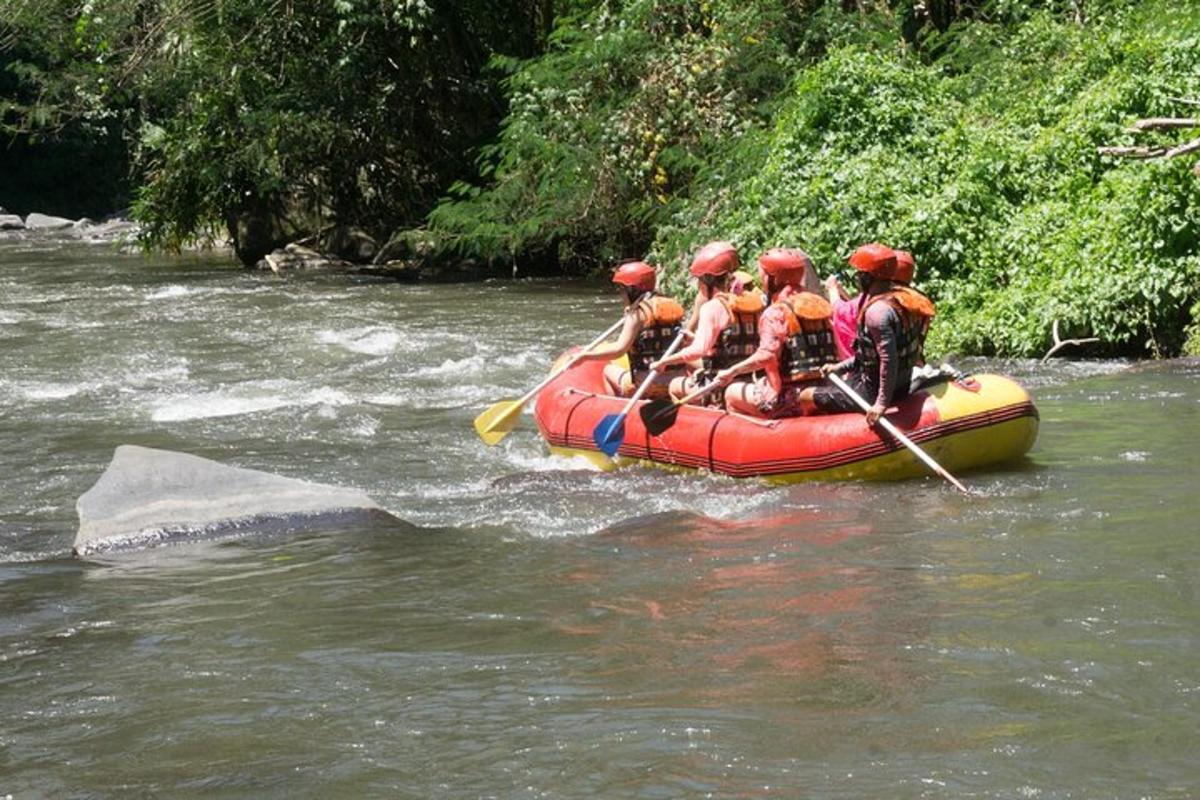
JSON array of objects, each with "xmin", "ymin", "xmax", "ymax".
[{"xmin": 0, "ymin": 240, "xmax": 1200, "ymax": 799}]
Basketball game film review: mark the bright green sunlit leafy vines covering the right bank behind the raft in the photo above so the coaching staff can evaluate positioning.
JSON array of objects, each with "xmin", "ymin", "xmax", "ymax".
[{"xmin": 655, "ymin": 4, "xmax": 1200, "ymax": 355}]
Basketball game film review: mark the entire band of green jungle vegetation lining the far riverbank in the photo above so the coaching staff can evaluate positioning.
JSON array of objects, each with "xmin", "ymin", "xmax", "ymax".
[{"xmin": 0, "ymin": 0, "xmax": 1200, "ymax": 356}]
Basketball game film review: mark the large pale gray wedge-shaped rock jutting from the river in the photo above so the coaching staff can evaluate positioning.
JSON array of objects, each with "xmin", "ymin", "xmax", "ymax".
[{"xmin": 74, "ymin": 445, "xmax": 386, "ymax": 555}]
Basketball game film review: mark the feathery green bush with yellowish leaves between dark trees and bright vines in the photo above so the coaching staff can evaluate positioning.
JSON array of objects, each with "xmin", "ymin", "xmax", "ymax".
[{"xmin": 430, "ymin": 0, "xmax": 803, "ymax": 267}]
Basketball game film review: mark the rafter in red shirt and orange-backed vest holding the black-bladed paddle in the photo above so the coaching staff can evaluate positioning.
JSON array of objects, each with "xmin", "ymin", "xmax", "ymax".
[{"xmin": 714, "ymin": 248, "xmax": 836, "ymax": 417}]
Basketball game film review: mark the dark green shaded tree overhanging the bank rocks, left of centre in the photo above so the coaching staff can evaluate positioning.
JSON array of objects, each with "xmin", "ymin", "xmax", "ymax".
[{"xmin": 136, "ymin": 0, "xmax": 544, "ymax": 250}]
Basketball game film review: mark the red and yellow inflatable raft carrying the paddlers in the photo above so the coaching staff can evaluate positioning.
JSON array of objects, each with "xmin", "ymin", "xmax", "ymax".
[{"xmin": 534, "ymin": 361, "xmax": 1038, "ymax": 482}]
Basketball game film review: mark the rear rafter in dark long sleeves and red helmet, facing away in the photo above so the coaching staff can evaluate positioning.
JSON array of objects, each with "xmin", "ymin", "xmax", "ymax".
[{"xmin": 816, "ymin": 242, "xmax": 934, "ymax": 425}]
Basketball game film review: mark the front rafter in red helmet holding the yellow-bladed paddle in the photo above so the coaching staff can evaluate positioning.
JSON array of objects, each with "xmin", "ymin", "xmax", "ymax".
[{"xmin": 580, "ymin": 261, "xmax": 684, "ymax": 399}]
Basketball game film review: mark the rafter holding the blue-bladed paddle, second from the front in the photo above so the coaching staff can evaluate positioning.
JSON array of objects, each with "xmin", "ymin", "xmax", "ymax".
[{"xmin": 650, "ymin": 241, "xmax": 766, "ymax": 403}]
